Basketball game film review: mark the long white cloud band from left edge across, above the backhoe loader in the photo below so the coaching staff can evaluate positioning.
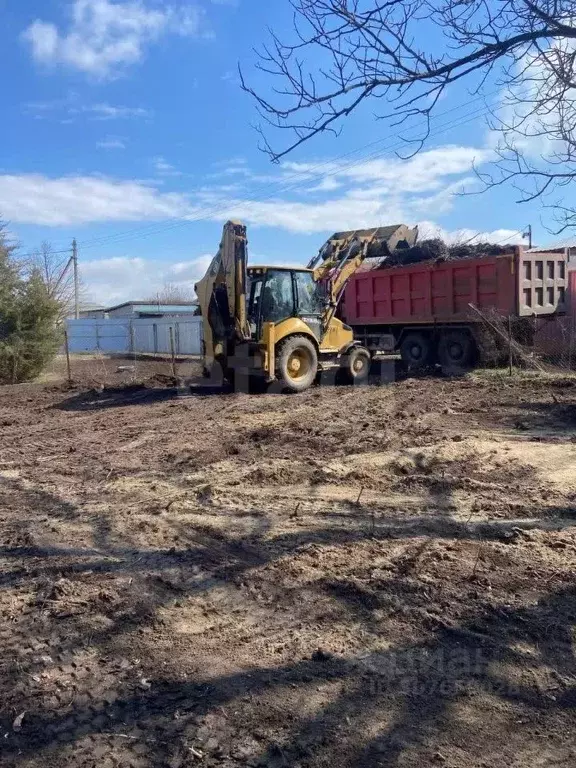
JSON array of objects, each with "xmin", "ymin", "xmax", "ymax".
[{"xmin": 0, "ymin": 140, "xmax": 508, "ymax": 234}]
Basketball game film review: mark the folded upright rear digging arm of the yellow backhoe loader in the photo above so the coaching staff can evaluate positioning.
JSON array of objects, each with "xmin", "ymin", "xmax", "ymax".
[{"xmin": 195, "ymin": 221, "xmax": 250, "ymax": 369}]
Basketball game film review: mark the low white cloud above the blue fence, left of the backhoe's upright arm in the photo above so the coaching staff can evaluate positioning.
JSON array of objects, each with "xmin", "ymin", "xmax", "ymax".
[{"xmin": 80, "ymin": 254, "xmax": 213, "ymax": 306}]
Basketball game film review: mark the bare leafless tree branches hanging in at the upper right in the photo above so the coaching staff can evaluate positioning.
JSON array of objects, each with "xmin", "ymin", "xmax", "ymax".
[{"xmin": 241, "ymin": 0, "xmax": 576, "ymax": 230}]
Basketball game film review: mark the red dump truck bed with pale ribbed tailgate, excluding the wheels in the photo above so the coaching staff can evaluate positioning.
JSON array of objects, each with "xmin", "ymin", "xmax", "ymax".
[{"xmin": 343, "ymin": 247, "xmax": 567, "ymax": 325}]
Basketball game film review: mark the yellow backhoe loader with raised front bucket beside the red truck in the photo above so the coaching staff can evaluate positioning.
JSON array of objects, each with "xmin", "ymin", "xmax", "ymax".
[{"xmin": 196, "ymin": 221, "xmax": 418, "ymax": 392}]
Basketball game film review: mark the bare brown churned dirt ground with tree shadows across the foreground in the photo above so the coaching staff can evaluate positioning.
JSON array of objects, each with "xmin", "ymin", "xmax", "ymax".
[{"xmin": 0, "ymin": 374, "xmax": 576, "ymax": 768}]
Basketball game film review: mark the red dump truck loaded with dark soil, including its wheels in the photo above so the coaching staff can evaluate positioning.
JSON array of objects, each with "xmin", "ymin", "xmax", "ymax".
[{"xmin": 342, "ymin": 246, "xmax": 568, "ymax": 370}]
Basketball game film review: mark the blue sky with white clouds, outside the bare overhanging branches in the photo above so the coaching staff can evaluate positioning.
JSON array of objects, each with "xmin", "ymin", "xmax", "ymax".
[{"xmin": 0, "ymin": 0, "xmax": 551, "ymax": 304}]
